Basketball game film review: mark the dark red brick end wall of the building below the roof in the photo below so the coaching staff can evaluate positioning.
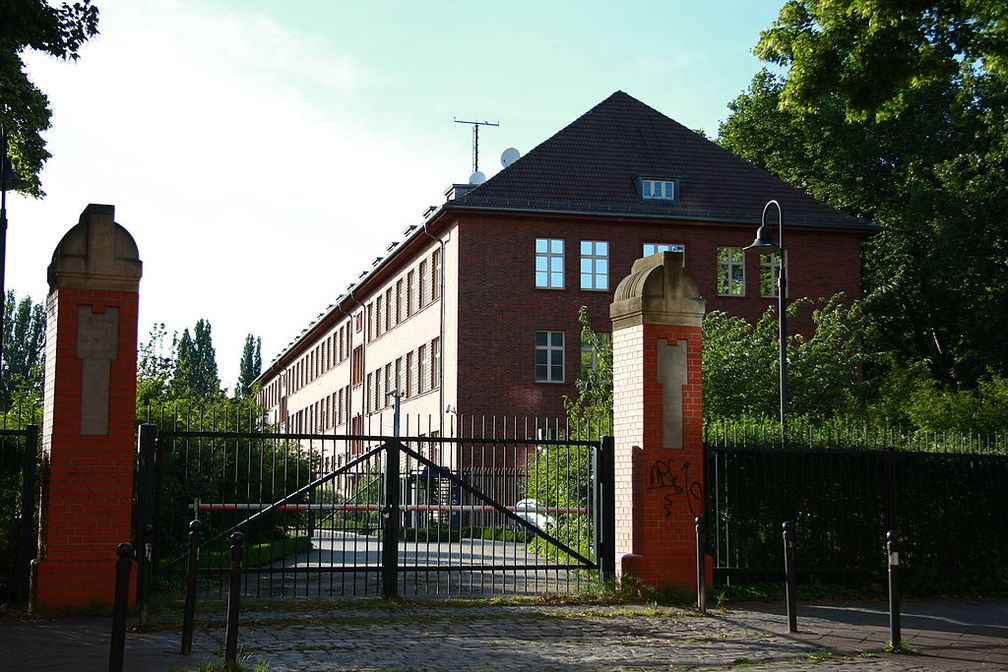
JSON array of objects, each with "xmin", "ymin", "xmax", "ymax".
[{"xmin": 458, "ymin": 215, "xmax": 861, "ymax": 417}]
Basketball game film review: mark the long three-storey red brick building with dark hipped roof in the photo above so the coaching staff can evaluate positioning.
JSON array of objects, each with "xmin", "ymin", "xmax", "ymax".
[{"xmin": 259, "ymin": 92, "xmax": 874, "ymax": 451}]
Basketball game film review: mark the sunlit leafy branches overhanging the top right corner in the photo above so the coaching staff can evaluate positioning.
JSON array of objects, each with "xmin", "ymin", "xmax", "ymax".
[{"xmin": 755, "ymin": 0, "xmax": 1008, "ymax": 119}]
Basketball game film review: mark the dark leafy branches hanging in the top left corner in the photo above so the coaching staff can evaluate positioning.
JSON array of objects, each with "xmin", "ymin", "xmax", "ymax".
[{"xmin": 0, "ymin": 0, "xmax": 98, "ymax": 196}]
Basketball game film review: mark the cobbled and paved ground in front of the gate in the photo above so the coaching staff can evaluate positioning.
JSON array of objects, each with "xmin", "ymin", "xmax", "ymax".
[{"xmin": 0, "ymin": 601, "xmax": 1008, "ymax": 672}]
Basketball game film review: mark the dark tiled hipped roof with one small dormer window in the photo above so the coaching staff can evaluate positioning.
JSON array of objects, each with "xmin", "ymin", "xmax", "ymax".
[{"xmin": 449, "ymin": 91, "xmax": 875, "ymax": 230}]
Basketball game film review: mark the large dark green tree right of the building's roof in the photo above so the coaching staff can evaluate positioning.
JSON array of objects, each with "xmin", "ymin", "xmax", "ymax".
[{"xmin": 719, "ymin": 72, "xmax": 1008, "ymax": 389}]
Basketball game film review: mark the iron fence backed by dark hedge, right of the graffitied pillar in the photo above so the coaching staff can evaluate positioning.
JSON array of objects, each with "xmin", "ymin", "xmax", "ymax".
[{"xmin": 705, "ymin": 427, "xmax": 1008, "ymax": 594}]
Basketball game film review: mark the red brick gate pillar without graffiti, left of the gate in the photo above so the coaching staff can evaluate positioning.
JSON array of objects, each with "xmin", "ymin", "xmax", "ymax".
[{"xmin": 32, "ymin": 205, "xmax": 142, "ymax": 610}]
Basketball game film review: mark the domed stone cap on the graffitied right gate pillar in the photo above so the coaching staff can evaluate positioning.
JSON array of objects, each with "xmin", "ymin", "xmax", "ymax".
[{"xmin": 609, "ymin": 252, "xmax": 705, "ymax": 330}]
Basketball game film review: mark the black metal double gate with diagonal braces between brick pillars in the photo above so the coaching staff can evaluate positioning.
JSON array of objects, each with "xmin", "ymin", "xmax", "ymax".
[{"xmin": 138, "ymin": 413, "xmax": 615, "ymax": 597}]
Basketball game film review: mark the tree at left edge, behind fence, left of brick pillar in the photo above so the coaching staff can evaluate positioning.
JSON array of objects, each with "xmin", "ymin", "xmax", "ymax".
[{"xmin": 0, "ymin": 290, "xmax": 45, "ymax": 410}]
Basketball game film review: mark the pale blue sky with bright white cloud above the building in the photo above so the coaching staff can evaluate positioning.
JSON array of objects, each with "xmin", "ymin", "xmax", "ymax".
[{"xmin": 6, "ymin": 0, "xmax": 782, "ymax": 387}]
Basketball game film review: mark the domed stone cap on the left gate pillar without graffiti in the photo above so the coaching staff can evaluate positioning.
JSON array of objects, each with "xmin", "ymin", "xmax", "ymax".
[{"xmin": 47, "ymin": 204, "xmax": 143, "ymax": 292}]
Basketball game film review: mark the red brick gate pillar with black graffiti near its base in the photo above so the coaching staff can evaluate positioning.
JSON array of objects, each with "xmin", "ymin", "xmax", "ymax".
[{"xmin": 610, "ymin": 252, "xmax": 704, "ymax": 587}]
